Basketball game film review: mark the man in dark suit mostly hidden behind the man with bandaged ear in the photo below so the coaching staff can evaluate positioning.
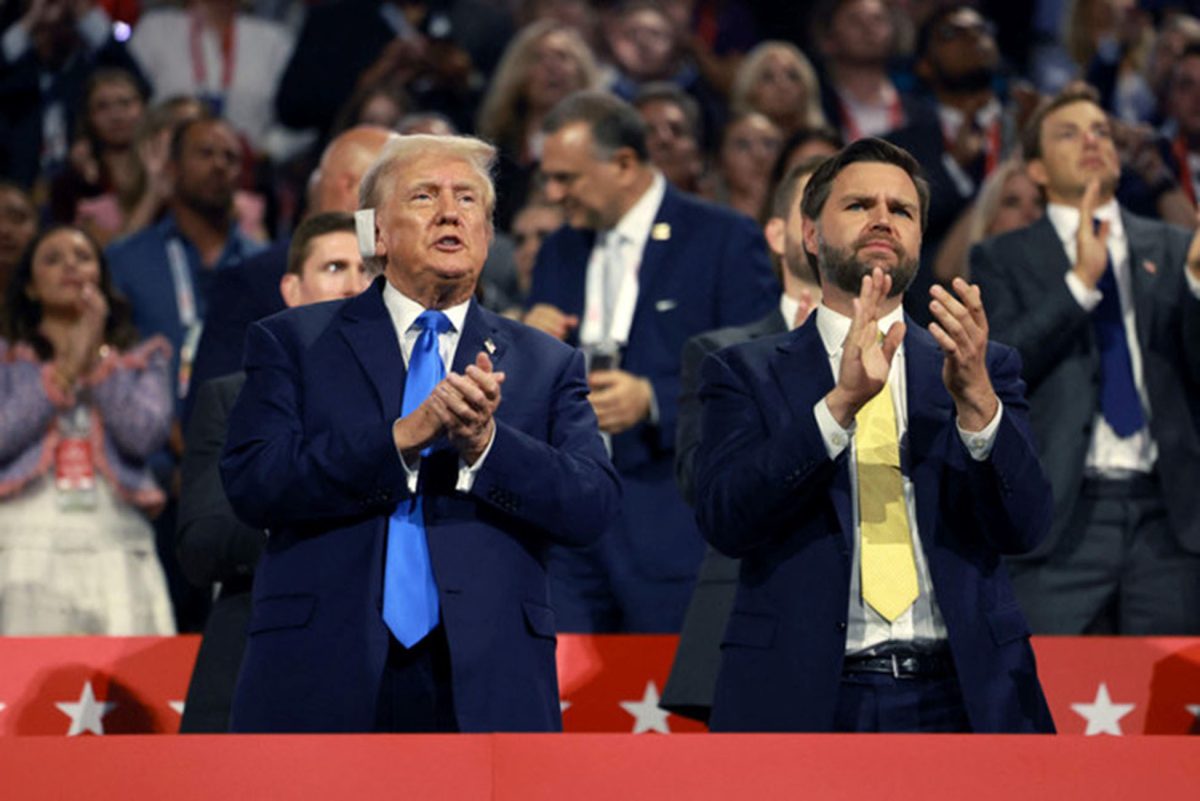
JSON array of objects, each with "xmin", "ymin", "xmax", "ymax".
[{"xmin": 178, "ymin": 211, "xmax": 371, "ymax": 734}]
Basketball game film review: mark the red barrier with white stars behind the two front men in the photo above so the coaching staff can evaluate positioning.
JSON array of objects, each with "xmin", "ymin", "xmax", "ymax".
[{"xmin": 0, "ymin": 634, "xmax": 1200, "ymax": 733}]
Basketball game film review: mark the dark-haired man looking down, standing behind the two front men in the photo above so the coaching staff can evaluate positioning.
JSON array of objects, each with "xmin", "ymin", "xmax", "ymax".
[{"xmin": 526, "ymin": 92, "xmax": 779, "ymax": 632}]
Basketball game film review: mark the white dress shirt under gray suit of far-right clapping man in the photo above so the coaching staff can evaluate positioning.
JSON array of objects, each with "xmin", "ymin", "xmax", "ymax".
[{"xmin": 1046, "ymin": 200, "xmax": 1158, "ymax": 478}]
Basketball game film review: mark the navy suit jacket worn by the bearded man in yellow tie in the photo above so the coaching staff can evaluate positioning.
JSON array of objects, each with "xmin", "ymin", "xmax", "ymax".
[{"xmin": 696, "ymin": 315, "xmax": 1054, "ymax": 731}]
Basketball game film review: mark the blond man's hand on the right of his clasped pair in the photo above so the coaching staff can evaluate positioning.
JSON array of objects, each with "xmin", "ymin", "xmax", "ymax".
[{"xmin": 430, "ymin": 353, "xmax": 504, "ymax": 464}]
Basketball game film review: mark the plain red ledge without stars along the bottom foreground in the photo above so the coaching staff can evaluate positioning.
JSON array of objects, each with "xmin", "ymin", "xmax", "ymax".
[{"xmin": 0, "ymin": 734, "xmax": 1200, "ymax": 801}]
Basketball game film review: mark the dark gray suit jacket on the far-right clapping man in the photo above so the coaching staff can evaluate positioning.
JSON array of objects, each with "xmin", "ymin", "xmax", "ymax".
[{"xmin": 971, "ymin": 210, "xmax": 1200, "ymax": 558}]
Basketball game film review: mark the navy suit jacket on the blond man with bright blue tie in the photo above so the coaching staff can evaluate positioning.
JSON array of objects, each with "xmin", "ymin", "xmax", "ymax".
[{"xmin": 221, "ymin": 278, "xmax": 619, "ymax": 731}]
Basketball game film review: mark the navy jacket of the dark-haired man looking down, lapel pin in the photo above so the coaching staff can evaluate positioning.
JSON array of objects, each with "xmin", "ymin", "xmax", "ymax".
[{"xmin": 529, "ymin": 186, "xmax": 779, "ymax": 578}]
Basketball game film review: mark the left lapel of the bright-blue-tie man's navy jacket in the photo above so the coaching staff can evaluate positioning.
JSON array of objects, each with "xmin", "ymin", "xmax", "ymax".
[{"xmin": 341, "ymin": 277, "xmax": 404, "ymax": 417}]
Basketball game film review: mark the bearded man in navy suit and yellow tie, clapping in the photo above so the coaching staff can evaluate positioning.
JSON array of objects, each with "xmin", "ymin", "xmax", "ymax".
[{"xmin": 696, "ymin": 139, "xmax": 1054, "ymax": 731}]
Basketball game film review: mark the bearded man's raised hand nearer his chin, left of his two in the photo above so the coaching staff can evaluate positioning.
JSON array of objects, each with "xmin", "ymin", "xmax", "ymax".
[{"xmin": 826, "ymin": 267, "xmax": 905, "ymax": 428}]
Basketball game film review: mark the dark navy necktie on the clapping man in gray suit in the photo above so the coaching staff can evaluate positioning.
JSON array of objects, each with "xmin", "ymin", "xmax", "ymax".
[{"xmin": 1092, "ymin": 221, "xmax": 1146, "ymax": 438}]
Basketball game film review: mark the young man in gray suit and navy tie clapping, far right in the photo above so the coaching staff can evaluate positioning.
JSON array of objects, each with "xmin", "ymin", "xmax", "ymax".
[{"xmin": 971, "ymin": 88, "xmax": 1200, "ymax": 634}]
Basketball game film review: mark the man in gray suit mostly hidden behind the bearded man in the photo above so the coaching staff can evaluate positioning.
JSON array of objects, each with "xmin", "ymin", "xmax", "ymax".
[{"xmin": 659, "ymin": 156, "xmax": 826, "ymax": 723}]
